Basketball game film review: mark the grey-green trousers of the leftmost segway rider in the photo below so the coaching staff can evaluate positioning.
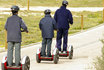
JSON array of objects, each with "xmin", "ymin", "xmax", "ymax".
[{"xmin": 7, "ymin": 42, "xmax": 21, "ymax": 66}]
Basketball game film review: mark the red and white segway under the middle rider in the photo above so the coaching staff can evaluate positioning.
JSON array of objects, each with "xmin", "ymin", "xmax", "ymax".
[{"xmin": 36, "ymin": 48, "xmax": 59, "ymax": 64}]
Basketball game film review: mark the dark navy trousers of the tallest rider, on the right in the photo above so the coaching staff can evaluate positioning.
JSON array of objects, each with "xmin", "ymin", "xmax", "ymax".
[{"xmin": 57, "ymin": 29, "xmax": 68, "ymax": 51}]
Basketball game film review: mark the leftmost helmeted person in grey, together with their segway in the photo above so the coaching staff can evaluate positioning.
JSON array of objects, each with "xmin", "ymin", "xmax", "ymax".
[{"xmin": 2, "ymin": 6, "xmax": 30, "ymax": 70}]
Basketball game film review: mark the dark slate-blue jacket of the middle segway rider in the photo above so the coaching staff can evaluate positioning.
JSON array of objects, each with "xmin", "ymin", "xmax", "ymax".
[{"xmin": 39, "ymin": 14, "xmax": 56, "ymax": 38}]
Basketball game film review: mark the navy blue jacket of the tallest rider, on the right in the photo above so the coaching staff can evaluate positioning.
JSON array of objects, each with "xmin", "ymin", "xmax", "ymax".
[{"xmin": 54, "ymin": 6, "xmax": 73, "ymax": 29}]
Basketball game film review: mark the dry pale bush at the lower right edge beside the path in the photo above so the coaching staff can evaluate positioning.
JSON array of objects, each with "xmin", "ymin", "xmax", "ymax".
[{"xmin": 95, "ymin": 40, "xmax": 104, "ymax": 70}]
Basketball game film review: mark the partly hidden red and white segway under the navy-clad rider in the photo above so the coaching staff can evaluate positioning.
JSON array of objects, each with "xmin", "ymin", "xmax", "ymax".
[{"xmin": 59, "ymin": 45, "xmax": 73, "ymax": 59}]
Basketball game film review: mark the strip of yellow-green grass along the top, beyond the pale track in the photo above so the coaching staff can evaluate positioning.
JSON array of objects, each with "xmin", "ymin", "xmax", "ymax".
[{"xmin": 0, "ymin": 0, "xmax": 102, "ymax": 7}]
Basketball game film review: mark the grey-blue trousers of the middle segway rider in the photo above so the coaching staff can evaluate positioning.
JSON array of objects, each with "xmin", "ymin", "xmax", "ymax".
[{"xmin": 41, "ymin": 38, "xmax": 52, "ymax": 56}]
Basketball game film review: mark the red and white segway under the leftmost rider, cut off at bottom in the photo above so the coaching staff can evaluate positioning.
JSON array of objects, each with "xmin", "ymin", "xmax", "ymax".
[{"xmin": 1, "ymin": 56, "xmax": 30, "ymax": 70}]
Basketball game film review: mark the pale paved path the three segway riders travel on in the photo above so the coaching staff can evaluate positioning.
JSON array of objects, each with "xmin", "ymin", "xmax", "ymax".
[{"xmin": 0, "ymin": 24, "xmax": 104, "ymax": 70}]
